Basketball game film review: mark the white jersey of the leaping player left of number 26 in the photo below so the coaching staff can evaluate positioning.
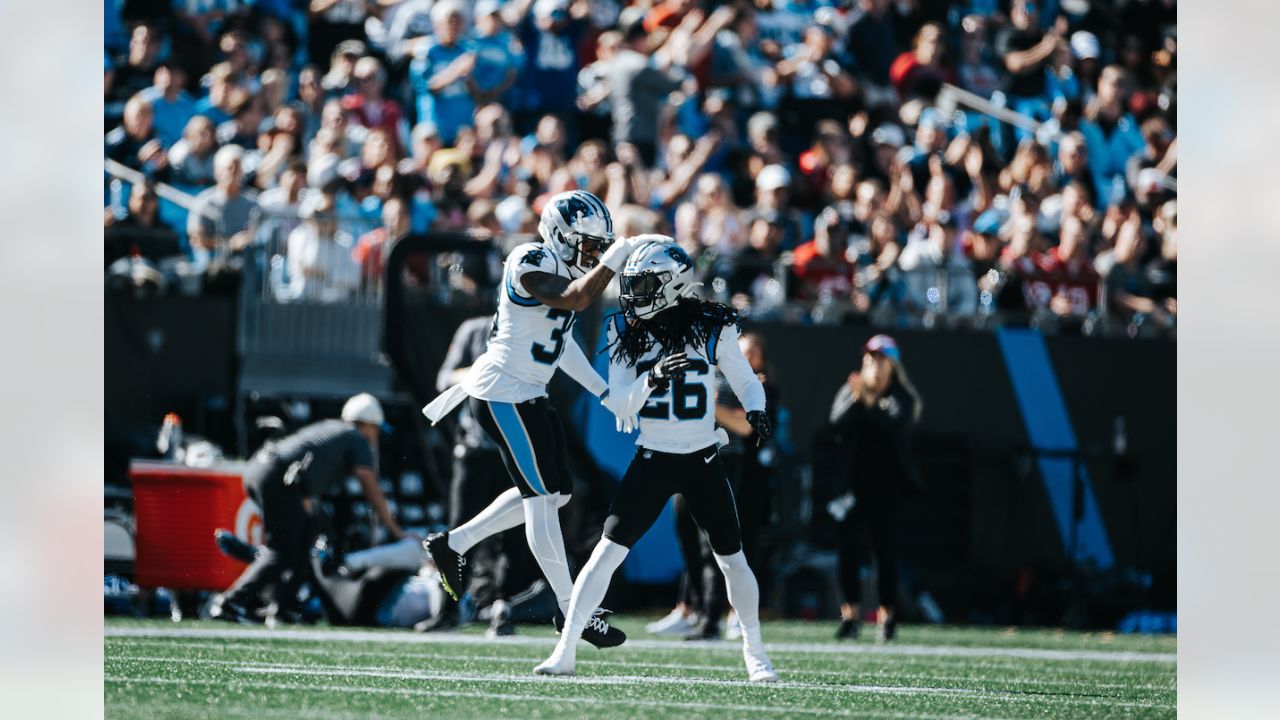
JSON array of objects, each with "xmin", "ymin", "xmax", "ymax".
[{"xmin": 462, "ymin": 242, "xmax": 573, "ymax": 402}]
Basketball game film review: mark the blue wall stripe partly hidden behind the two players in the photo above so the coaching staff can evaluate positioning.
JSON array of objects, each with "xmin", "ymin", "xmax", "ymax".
[{"xmin": 576, "ymin": 315, "xmax": 685, "ymax": 584}]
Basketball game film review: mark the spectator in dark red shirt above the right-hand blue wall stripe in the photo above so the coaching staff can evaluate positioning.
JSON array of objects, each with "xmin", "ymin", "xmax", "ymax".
[{"xmin": 1024, "ymin": 217, "xmax": 1098, "ymax": 318}]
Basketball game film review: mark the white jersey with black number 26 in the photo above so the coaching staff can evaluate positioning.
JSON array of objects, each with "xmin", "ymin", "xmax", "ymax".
[{"xmin": 605, "ymin": 313, "xmax": 764, "ymax": 455}]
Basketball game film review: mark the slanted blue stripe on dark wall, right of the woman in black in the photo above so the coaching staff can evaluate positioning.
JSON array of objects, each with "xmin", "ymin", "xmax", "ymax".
[{"xmin": 996, "ymin": 328, "xmax": 1115, "ymax": 569}]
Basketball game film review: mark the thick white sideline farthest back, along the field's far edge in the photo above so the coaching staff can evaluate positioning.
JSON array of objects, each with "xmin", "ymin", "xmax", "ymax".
[{"xmin": 104, "ymin": 628, "xmax": 1178, "ymax": 662}]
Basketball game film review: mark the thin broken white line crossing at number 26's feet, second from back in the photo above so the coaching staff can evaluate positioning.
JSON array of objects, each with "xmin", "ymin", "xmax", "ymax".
[{"xmin": 112, "ymin": 642, "xmax": 1176, "ymax": 691}]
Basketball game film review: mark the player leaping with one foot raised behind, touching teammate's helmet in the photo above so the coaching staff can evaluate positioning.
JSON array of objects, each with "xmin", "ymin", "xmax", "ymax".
[{"xmin": 424, "ymin": 190, "xmax": 636, "ymax": 647}]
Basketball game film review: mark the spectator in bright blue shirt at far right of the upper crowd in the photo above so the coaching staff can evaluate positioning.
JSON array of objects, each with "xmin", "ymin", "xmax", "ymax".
[{"xmin": 1080, "ymin": 65, "xmax": 1146, "ymax": 200}]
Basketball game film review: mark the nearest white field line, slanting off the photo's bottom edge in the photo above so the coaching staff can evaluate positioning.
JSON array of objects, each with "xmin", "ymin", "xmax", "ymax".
[{"xmin": 105, "ymin": 675, "xmax": 982, "ymax": 720}]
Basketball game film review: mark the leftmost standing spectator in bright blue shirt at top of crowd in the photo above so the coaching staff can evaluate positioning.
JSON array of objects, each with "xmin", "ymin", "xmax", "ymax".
[{"xmin": 410, "ymin": 0, "xmax": 476, "ymax": 145}]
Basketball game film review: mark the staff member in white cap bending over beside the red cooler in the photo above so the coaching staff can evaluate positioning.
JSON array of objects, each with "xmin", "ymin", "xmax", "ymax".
[{"xmin": 209, "ymin": 393, "xmax": 406, "ymax": 624}]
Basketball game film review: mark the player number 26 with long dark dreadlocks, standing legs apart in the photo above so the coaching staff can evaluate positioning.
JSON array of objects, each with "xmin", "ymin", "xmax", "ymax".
[{"xmin": 534, "ymin": 238, "xmax": 778, "ymax": 682}]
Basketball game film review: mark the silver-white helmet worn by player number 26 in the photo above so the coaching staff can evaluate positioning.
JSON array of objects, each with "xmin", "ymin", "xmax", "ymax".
[{"xmin": 618, "ymin": 236, "xmax": 701, "ymax": 319}]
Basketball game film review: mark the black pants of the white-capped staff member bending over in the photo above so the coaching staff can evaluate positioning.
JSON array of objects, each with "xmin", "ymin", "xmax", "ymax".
[{"xmin": 227, "ymin": 452, "xmax": 315, "ymax": 609}]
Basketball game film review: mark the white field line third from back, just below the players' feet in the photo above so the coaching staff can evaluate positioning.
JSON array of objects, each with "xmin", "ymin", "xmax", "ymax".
[{"xmin": 104, "ymin": 655, "xmax": 1172, "ymax": 710}]
